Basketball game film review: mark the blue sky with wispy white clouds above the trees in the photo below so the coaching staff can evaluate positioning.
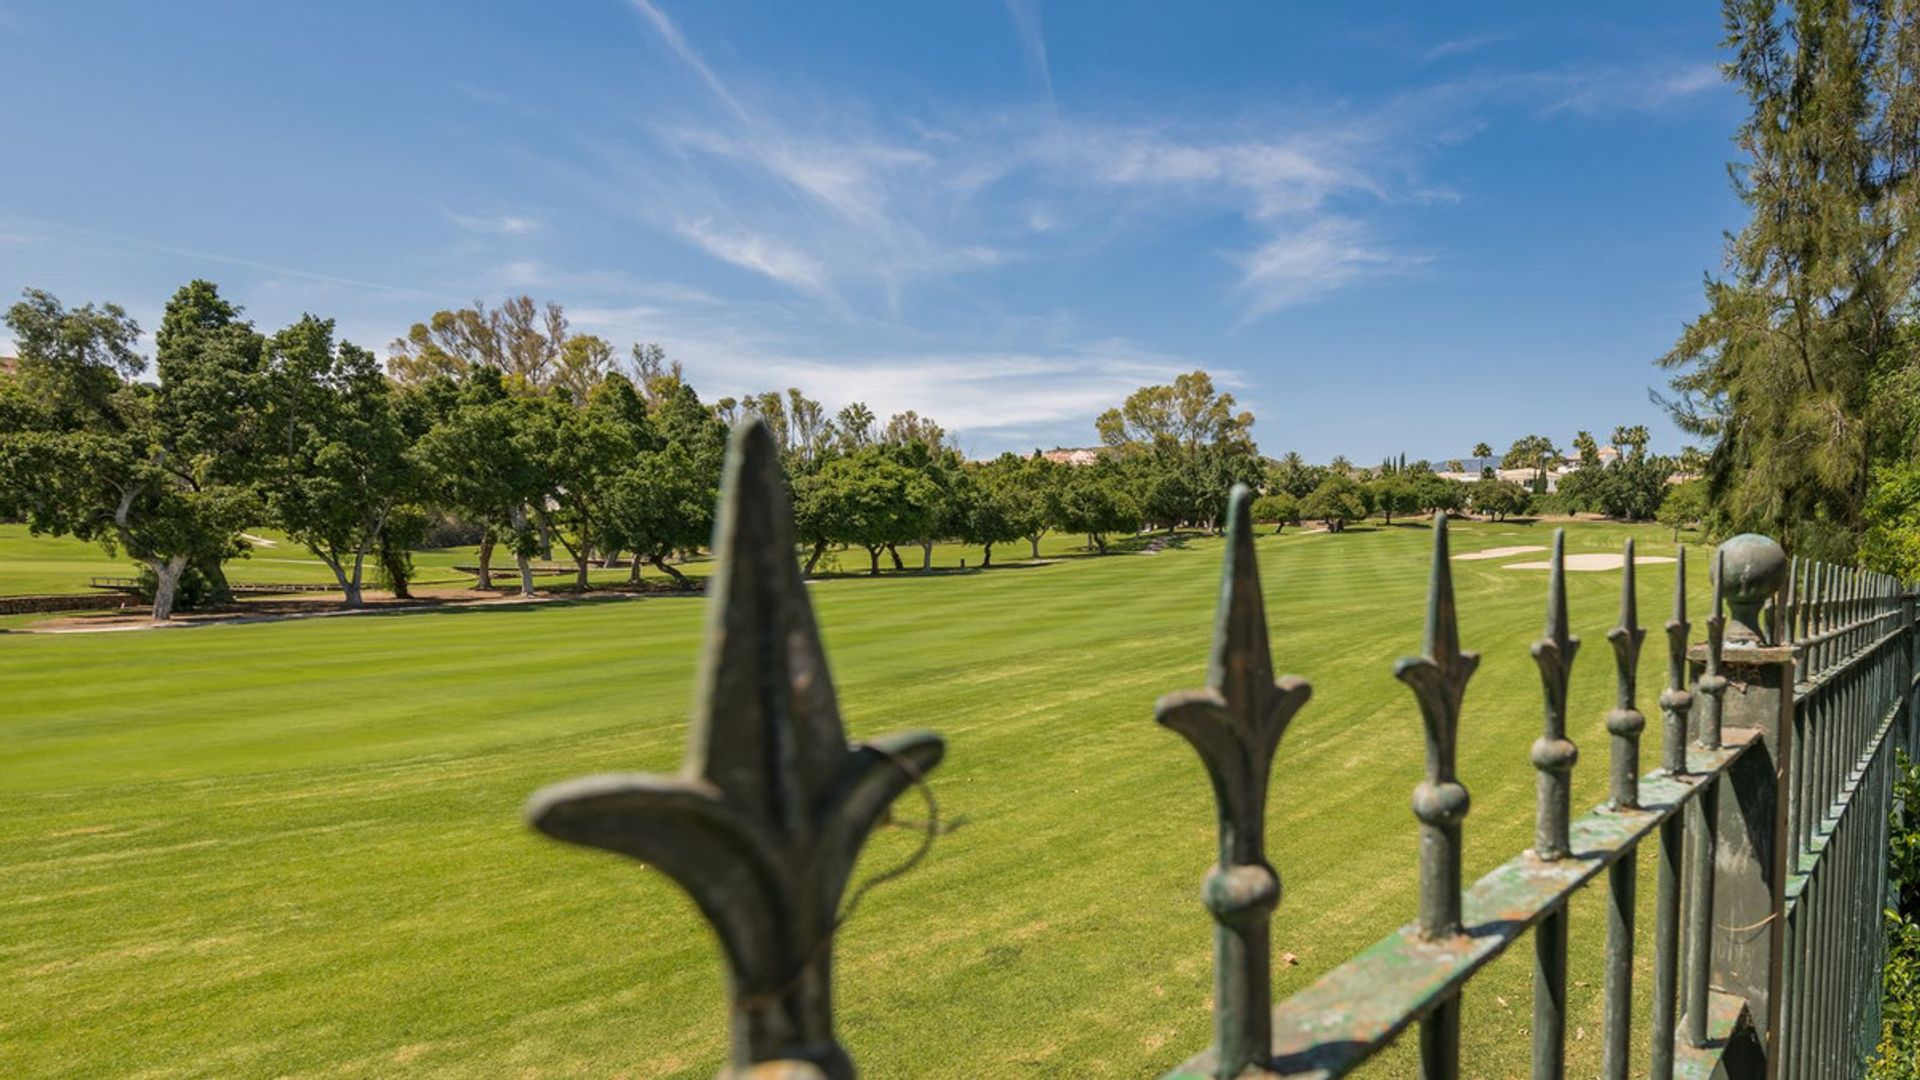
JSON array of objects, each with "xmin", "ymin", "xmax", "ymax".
[{"xmin": 0, "ymin": 0, "xmax": 1741, "ymax": 463}]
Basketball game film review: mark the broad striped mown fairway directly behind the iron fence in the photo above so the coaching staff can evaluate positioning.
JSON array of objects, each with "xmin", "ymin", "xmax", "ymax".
[{"xmin": 0, "ymin": 525, "xmax": 1705, "ymax": 1078}]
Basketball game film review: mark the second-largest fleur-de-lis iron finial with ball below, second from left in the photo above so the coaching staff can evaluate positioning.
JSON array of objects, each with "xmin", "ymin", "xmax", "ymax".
[{"xmin": 1154, "ymin": 484, "xmax": 1311, "ymax": 1076}]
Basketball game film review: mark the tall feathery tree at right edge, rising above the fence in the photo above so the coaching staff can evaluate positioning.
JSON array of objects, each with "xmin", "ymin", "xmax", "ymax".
[{"xmin": 1661, "ymin": 0, "xmax": 1920, "ymax": 559}]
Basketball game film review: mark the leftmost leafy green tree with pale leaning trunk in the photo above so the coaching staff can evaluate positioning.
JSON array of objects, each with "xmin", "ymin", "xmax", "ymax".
[{"xmin": 0, "ymin": 290, "xmax": 257, "ymax": 619}]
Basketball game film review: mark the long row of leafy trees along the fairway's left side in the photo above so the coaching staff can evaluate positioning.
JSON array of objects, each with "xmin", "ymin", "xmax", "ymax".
[{"xmin": 0, "ymin": 281, "xmax": 1290, "ymax": 619}]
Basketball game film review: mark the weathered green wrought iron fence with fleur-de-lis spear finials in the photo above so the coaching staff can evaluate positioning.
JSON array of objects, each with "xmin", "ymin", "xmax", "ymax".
[{"xmin": 528, "ymin": 421, "xmax": 1920, "ymax": 1080}]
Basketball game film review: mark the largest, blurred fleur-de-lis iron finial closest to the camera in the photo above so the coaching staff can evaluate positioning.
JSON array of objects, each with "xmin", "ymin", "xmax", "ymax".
[{"xmin": 526, "ymin": 419, "xmax": 943, "ymax": 1080}]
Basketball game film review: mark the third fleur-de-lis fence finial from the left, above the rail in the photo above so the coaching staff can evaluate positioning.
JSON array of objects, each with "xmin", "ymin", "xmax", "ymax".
[{"xmin": 1394, "ymin": 511, "xmax": 1480, "ymax": 938}]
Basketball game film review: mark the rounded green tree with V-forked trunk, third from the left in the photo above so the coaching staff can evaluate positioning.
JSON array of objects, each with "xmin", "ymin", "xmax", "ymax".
[{"xmin": 265, "ymin": 315, "xmax": 420, "ymax": 607}]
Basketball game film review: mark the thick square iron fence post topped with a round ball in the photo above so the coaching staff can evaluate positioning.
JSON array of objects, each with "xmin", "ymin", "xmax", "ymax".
[{"xmin": 1693, "ymin": 532, "xmax": 1793, "ymax": 1074}]
